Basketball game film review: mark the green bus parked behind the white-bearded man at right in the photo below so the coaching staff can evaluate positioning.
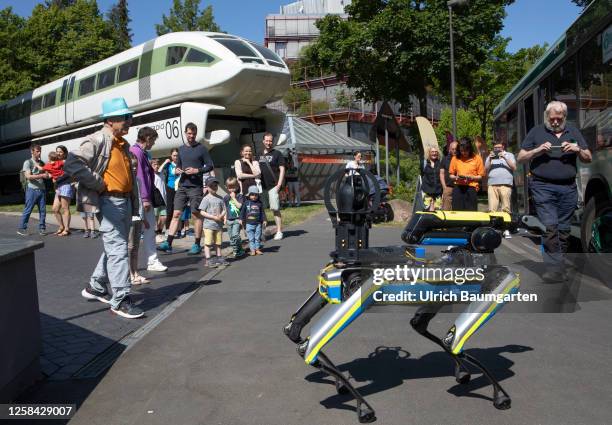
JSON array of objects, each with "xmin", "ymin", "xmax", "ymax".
[{"xmin": 493, "ymin": 0, "xmax": 612, "ymax": 252}]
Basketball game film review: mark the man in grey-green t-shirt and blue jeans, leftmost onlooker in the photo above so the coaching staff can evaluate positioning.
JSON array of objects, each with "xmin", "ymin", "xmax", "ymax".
[{"xmin": 17, "ymin": 143, "xmax": 51, "ymax": 236}]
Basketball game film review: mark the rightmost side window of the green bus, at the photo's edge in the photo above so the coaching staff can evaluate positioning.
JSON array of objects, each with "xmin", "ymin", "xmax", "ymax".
[{"xmin": 579, "ymin": 30, "xmax": 612, "ymax": 150}]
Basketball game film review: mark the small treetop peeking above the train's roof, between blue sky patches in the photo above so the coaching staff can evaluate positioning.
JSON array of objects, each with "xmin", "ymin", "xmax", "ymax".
[{"xmin": 155, "ymin": 0, "xmax": 221, "ymax": 35}]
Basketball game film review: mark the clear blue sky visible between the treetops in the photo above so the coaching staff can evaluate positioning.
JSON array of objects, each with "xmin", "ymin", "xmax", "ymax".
[{"xmin": 0, "ymin": 0, "xmax": 580, "ymax": 52}]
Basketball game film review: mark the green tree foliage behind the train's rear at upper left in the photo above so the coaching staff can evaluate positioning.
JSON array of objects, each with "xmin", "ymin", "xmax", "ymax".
[{"xmin": 0, "ymin": 0, "xmax": 129, "ymax": 101}]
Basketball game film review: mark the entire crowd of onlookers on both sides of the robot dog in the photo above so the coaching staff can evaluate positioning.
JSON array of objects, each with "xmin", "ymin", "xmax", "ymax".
[{"xmin": 17, "ymin": 98, "xmax": 591, "ymax": 318}]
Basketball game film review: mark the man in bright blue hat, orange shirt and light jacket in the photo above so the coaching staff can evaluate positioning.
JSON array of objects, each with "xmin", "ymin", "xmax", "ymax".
[{"xmin": 64, "ymin": 97, "xmax": 144, "ymax": 319}]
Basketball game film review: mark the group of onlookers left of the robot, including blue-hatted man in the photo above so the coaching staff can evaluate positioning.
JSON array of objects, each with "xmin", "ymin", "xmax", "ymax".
[{"xmin": 17, "ymin": 98, "xmax": 300, "ymax": 318}]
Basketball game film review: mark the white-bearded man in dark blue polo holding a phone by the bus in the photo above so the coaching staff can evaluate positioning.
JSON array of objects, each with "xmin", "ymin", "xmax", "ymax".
[{"xmin": 517, "ymin": 101, "xmax": 591, "ymax": 282}]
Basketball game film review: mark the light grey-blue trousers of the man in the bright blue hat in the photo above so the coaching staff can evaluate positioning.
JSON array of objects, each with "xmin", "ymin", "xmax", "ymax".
[{"xmin": 89, "ymin": 196, "xmax": 132, "ymax": 308}]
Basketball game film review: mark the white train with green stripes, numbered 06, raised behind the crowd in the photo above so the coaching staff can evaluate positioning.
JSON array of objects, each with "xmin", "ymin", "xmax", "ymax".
[{"xmin": 0, "ymin": 32, "xmax": 290, "ymax": 192}]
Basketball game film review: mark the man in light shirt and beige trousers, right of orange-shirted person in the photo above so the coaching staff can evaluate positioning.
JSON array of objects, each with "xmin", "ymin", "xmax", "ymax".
[{"xmin": 485, "ymin": 142, "xmax": 516, "ymax": 239}]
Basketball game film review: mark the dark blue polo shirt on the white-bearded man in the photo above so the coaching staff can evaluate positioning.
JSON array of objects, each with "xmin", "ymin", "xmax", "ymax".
[{"xmin": 521, "ymin": 125, "xmax": 588, "ymax": 184}]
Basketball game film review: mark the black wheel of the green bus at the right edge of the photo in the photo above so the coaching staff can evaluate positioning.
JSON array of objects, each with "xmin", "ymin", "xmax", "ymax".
[{"xmin": 580, "ymin": 196, "xmax": 612, "ymax": 252}]
